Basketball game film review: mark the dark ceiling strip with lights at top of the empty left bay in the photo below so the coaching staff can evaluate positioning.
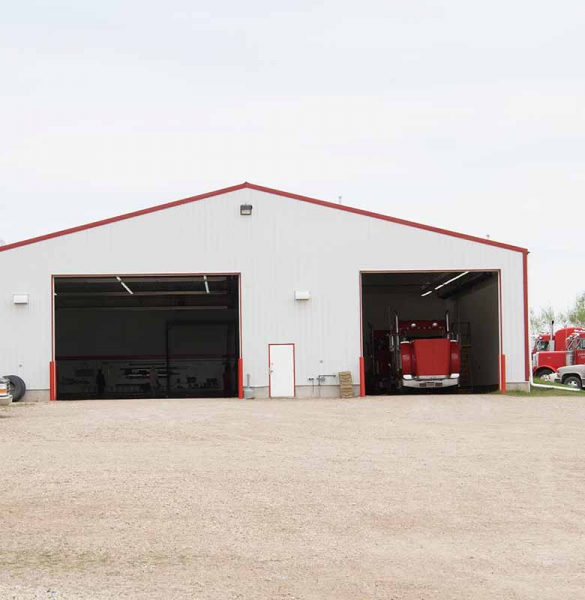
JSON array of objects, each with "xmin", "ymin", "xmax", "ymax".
[{"xmin": 54, "ymin": 275, "xmax": 238, "ymax": 310}]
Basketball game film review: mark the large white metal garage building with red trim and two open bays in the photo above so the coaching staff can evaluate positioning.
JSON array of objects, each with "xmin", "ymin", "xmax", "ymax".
[{"xmin": 0, "ymin": 183, "xmax": 530, "ymax": 400}]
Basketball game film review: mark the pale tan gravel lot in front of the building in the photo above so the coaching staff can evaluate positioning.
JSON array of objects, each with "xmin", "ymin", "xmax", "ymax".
[{"xmin": 0, "ymin": 396, "xmax": 585, "ymax": 600}]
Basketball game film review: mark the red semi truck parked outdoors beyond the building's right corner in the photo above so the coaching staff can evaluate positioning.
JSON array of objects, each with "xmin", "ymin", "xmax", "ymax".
[{"xmin": 532, "ymin": 327, "xmax": 585, "ymax": 377}]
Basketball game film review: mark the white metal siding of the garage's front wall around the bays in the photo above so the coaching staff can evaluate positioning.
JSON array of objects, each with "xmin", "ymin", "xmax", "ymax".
[{"xmin": 0, "ymin": 189, "xmax": 525, "ymax": 389}]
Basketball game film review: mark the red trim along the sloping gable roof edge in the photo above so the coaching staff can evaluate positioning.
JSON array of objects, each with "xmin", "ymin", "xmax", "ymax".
[{"xmin": 0, "ymin": 181, "xmax": 528, "ymax": 254}]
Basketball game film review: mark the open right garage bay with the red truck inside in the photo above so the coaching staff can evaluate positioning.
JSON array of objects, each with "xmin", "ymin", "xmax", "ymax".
[{"xmin": 362, "ymin": 271, "xmax": 500, "ymax": 394}]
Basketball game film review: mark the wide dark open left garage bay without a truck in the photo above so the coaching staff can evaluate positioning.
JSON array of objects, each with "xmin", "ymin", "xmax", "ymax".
[{"xmin": 54, "ymin": 275, "xmax": 240, "ymax": 400}]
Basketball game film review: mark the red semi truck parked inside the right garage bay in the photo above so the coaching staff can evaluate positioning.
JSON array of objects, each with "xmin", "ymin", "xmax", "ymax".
[{"xmin": 371, "ymin": 314, "xmax": 461, "ymax": 393}]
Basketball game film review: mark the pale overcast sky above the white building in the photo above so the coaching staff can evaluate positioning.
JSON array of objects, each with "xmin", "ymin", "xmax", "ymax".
[{"xmin": 0, "ymin": 0, "xmax": 585, "ymax": 308}]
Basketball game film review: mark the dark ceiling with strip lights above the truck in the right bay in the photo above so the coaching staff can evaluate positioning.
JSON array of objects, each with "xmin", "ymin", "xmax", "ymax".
[{"xmin": 362, "ymin": 271, "xmax": 494, "ymax": 299}]
